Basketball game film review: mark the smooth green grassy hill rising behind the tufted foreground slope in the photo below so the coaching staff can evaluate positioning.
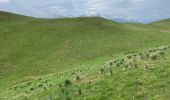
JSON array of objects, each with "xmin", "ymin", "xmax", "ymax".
[{"xmin": 0, "ymin": 12, "xmax": 170, "ymax": 99}]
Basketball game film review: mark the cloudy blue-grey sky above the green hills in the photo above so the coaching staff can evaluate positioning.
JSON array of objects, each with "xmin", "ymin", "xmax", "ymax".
[{"xmin": 0, "ymin": 0, "xmax": 170, "ymax": 23}]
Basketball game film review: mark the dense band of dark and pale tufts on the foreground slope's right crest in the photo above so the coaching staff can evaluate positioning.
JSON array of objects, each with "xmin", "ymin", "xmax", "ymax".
[{"xmin": 100, "ymin": 46, "xmax": 169, "ymax": 74}]
